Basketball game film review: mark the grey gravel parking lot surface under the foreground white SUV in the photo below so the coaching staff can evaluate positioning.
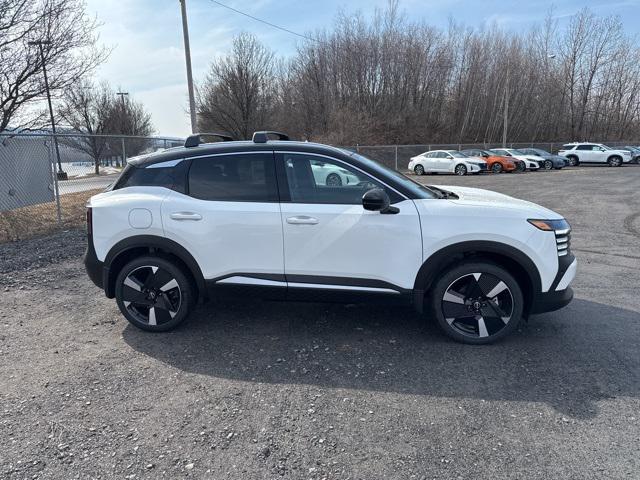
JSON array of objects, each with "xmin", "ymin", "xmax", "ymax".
[{"xmin": 0, "ymin": 166, "xmax": 640, "ymax": 479}]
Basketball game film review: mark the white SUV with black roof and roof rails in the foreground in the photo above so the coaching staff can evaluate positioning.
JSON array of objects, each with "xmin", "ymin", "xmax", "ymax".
[{"xmin": 85, "ymin": 132, "xmax": 577, "ymax": 343}]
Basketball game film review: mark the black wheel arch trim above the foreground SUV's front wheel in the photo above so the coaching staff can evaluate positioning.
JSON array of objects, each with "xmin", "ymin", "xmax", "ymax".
[{"xmin": 413, "ymin": 240, "xmax": 542, "ymax": 314}]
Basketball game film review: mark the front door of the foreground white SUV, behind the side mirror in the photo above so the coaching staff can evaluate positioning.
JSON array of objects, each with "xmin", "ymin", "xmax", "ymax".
[{"xmin": 276, "ymin": 151, "xmax": 422, "ymax": 294}]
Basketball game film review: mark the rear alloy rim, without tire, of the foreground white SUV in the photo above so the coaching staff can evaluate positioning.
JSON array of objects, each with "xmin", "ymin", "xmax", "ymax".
[{"xmin": 122, "ymin": 265, "xmax": 182, "ymax": 326}]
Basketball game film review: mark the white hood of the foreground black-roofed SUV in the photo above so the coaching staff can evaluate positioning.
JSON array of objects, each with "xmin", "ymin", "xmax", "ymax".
[{"xmin": 438, "ymin": 185, "xmax": 563, "ymax": 220}]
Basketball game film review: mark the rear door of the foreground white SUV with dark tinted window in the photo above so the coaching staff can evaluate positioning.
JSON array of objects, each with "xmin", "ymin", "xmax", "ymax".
[{"xmin": 162, "ymin": 151, "xmax": 286, "ymax": 289}]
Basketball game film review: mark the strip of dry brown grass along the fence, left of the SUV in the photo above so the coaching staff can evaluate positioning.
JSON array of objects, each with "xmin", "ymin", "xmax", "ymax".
[{"xmin": 0, "ymin": 189, "xmax": 102, "ymax": 243}]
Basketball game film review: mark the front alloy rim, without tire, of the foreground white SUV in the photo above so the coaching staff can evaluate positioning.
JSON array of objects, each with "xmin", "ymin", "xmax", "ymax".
[{"xmin": 442, "ymin": 272, "xmax": 514, "ymax": 338}]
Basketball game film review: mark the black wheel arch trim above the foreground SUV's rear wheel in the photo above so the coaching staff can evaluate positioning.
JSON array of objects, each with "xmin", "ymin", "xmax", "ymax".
[{"xmin": 102, "ymin": 235, "xmax": 207, "ymax": 298}]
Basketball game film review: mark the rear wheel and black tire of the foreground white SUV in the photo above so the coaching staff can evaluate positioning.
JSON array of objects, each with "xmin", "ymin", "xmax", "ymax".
[{"xmin": 115, "ymin": 256, "xmax": 195, "ymax": 332}]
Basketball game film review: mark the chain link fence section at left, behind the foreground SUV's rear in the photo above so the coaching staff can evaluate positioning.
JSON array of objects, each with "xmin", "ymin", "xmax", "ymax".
[{"xmin": 0, "ymin": 132, "xmax": 184, "ymax": 242}]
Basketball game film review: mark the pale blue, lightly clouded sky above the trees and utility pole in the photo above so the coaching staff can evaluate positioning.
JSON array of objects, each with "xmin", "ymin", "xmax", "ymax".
[{"xmin": 87, "ymin": 0, "xmax": 640, "ymax": 136}]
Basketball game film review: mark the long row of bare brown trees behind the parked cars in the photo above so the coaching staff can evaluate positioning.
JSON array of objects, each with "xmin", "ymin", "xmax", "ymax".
[{"xmin": 197, "ymin": 0, "xmax": 640, "ymax": 145}]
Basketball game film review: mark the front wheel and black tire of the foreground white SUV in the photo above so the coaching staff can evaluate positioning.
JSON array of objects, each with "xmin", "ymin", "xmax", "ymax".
[{"xmin": 428, "ymin": 260, "xmax": 524, "ymax": 345}]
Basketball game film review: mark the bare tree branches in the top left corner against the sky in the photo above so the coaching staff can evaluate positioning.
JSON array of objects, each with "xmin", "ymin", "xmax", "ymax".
[{"xmin": 0, "ymin": 0, "xmax": 106, "ymax": 131}]
